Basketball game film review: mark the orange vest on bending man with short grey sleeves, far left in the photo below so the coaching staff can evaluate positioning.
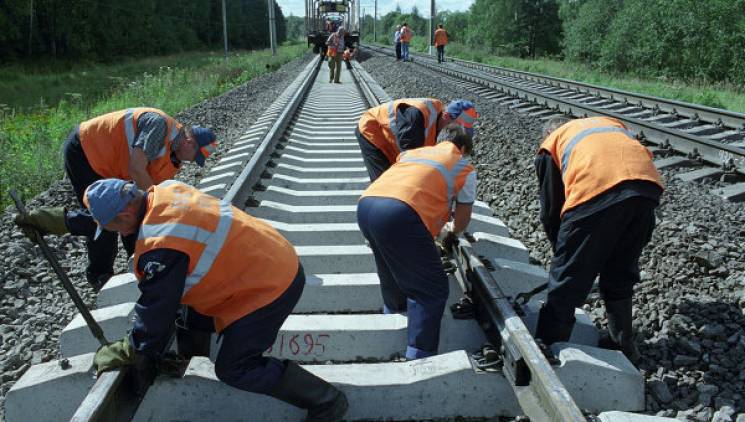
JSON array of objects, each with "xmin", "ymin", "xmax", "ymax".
[{"xmin": 80, "ymin": 107, "xmax": 181, "ymax": 184}]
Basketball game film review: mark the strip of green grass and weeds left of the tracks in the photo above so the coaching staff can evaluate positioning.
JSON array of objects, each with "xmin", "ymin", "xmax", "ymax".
[{"xmin": 0, "ymin": 44, "xmax": 307, "ymax": 207}]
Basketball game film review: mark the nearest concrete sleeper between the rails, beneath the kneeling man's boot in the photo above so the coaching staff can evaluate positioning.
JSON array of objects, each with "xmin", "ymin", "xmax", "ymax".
[{"xmin": 135, "ymin": 352, "xmax": 520, "ymax": 421}]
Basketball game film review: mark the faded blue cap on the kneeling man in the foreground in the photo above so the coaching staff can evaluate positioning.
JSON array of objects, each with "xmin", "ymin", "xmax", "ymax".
[{"xmin": 83, "ymin": 179, "xmax": 137, "ymax": 239}]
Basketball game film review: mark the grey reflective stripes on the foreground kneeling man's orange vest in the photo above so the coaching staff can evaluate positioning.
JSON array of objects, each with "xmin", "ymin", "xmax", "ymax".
[{"xmin": 138, "ymin": 180, "xmax": 233, "ymax": 296}]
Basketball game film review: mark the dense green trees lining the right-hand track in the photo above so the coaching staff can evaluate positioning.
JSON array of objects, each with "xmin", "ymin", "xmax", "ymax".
[{"xmin": 363, "ymin": 0, "xmax": 745, "ymax": 85}]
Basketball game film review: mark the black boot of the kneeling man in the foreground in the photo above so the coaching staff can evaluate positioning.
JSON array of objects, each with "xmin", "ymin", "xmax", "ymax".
[{"xmin": 268, "ymin": 361, "xmax": 349, "ymax": 422}]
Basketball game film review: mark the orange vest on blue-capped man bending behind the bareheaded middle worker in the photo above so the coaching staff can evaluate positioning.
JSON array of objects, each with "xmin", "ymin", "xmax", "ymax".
[{"xmin": 358, "ymin": 98, "xmax": 445, "ymax": 163}]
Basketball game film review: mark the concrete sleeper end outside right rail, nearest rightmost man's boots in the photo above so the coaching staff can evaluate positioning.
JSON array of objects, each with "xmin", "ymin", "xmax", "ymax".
[{"xmin": 551, "ymin": 343, "xmax": 644, "ymax": 413}]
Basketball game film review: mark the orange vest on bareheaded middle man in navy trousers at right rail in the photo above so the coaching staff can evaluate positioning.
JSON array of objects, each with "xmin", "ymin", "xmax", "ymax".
[{"xmin": 362, "ymin": 141, "xmax": 473, "ymax": 237}]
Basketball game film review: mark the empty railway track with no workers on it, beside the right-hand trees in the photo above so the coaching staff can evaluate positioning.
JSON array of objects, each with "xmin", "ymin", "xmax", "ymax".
[{"xmin": 365, "ymin": 46, "xmax": 745, "ymax": 201}]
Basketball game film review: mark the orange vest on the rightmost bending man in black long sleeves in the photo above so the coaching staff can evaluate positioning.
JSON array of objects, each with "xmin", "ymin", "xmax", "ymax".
[{"xmin": 540, "ymin": 117, "xmax": 664, "ymax": 216}]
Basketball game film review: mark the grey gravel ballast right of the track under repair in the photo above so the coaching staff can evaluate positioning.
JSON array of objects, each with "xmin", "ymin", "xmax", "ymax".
[{"xmin": 358, "ymin": 47, "xmax": 745, "ymax": 421}]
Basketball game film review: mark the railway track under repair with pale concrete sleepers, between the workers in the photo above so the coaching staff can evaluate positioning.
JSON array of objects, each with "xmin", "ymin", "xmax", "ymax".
[{"xmin": 5, "ymin": 54, "xmax": 644, "ymax": 422}]
